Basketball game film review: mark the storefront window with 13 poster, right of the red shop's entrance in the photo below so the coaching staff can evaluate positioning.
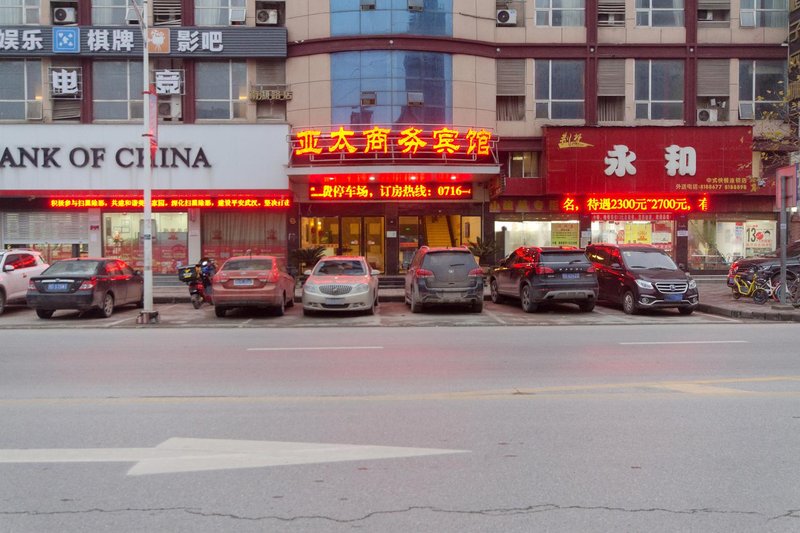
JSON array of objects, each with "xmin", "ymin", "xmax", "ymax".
[{"xmin": 689, "ymin": 218, "xmax": 777, "ymax": 270}]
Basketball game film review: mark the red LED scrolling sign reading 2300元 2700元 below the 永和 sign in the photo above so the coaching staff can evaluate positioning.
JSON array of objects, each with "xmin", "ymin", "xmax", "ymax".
[{"xmin": 561, "ymin": 195, "xmax": 710, "ymax": 213}]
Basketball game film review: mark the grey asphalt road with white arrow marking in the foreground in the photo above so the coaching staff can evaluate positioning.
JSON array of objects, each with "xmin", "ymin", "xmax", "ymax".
[{"xmin": 0, "ymin": 322, "xmax": 800, "ymax": 532}]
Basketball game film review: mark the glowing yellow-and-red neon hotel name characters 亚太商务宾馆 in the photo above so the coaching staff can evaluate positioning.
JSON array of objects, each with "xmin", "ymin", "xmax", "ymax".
[{"xmin": 292, "ymin": 125, "xmax": 497, "ymax": 163}]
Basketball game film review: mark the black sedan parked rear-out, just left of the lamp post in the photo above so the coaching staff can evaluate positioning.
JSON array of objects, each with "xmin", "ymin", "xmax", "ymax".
[{"xmin": 27, "ymin": 257, "xmax": 144, "ymax": 318}]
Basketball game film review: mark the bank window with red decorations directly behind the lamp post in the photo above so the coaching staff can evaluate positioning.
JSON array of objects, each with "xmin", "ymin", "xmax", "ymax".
[{"xmin": 103, "ymin": 213, "xmax": 189, "ymax": 274}]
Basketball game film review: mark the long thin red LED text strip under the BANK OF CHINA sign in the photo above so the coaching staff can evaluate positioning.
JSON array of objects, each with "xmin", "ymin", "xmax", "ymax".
[{"xmin": 47, "ymin": 195, "xmax": 292, "ymax": 209}]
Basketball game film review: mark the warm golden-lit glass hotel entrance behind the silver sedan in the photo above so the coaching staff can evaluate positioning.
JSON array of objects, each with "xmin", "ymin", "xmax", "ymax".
[{"xmin": 300, "ymin": 217, "xmax": 386, "ymax": 272}]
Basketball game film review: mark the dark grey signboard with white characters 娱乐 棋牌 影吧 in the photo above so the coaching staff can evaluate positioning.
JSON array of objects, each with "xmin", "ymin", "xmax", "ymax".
[{"xmin": 0, "ymin": 26, "xmax": 286, "ymax": 57}]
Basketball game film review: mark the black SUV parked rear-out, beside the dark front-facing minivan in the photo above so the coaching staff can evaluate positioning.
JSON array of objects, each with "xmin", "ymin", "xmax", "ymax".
[{"xmin": 489, "ymin": 246, "xmax": 598, "ymax": 313}]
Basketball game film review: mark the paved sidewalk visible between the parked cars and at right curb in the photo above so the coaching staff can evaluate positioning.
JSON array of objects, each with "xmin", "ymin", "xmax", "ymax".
[{"xmin": 153, "ymin": 276, "xmax": 800, "ymax": 322}]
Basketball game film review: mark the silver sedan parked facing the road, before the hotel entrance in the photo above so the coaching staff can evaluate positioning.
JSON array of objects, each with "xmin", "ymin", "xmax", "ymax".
[{"xmin": 303, "ymin": 256, "xmax": 380, "ymax": 315}]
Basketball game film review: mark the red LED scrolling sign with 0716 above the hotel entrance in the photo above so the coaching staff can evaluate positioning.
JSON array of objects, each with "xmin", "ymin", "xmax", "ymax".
[{"xmin": 308, "ymin": 183, "xmax": 472, "ymax": 201}]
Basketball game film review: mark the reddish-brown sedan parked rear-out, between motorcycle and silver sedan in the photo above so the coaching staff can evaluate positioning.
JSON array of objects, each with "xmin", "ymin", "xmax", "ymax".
[{"xmin": 211, "ymin": 255, "xmax": 295, "ymax": 317}]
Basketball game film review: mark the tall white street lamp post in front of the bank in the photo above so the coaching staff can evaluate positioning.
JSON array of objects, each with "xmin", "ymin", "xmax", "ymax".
[{"xmin": 131, "ymin": 0, "xmax": 158, "ymax": 324}]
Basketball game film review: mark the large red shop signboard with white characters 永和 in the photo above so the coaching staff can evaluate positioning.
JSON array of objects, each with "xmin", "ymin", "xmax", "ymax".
[{"xmin": 545, "ymin": 126, "xmax": 756, "ymax": 194}]
